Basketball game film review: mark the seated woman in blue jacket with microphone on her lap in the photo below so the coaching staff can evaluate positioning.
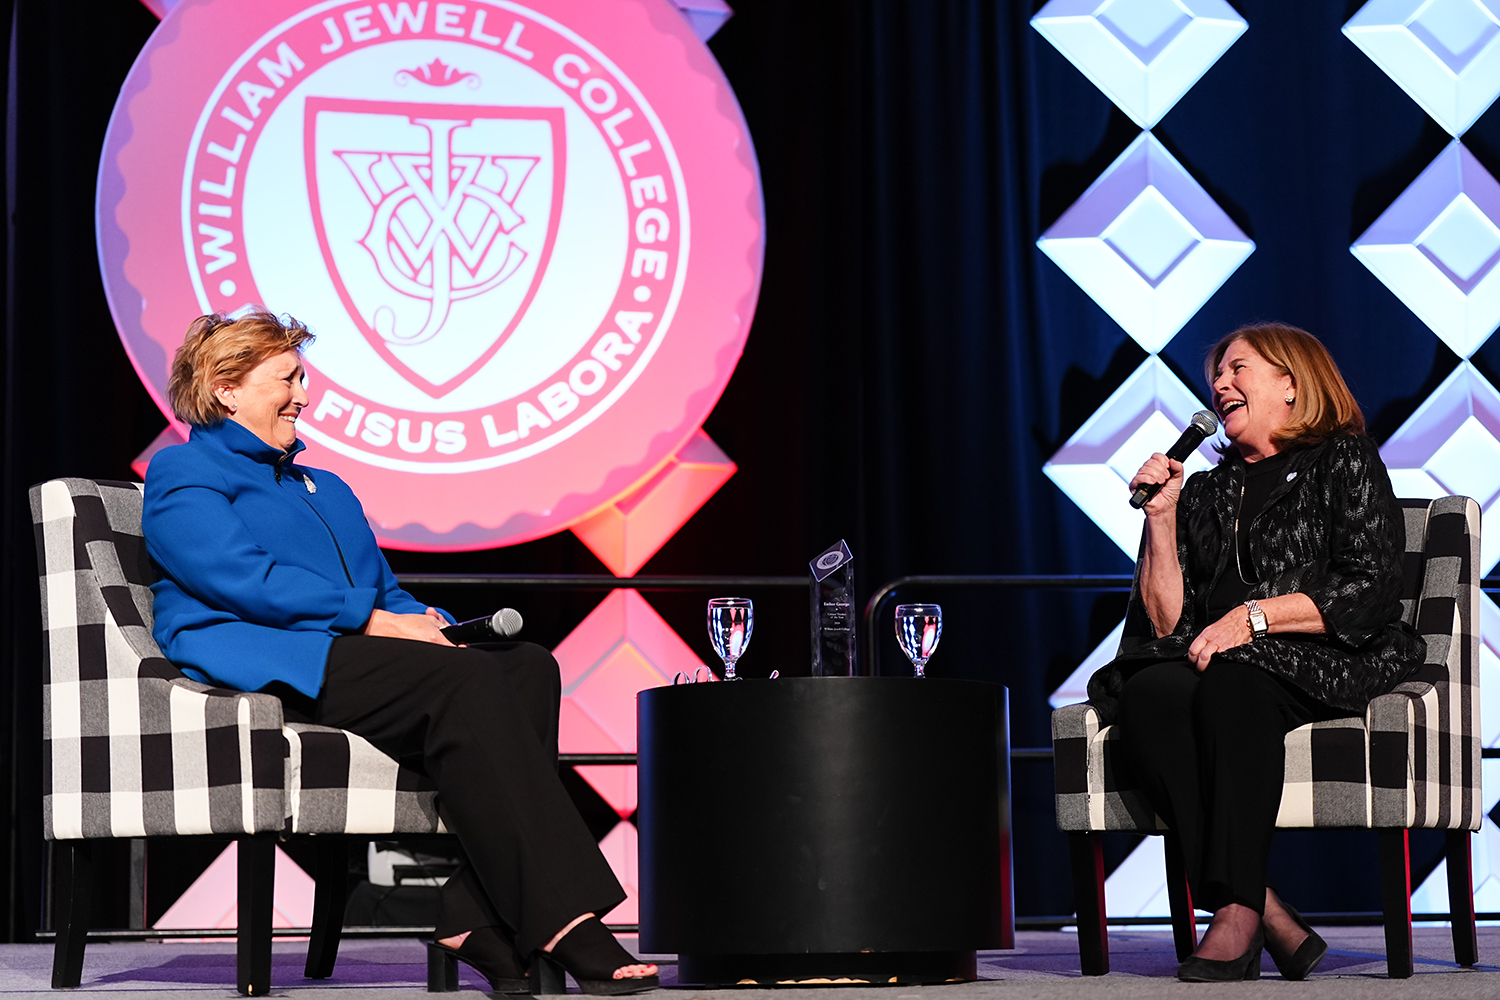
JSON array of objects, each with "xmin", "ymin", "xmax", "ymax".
[{"xmin": 143, "ymin": 312, "xmax": 657, "ymax": 994}]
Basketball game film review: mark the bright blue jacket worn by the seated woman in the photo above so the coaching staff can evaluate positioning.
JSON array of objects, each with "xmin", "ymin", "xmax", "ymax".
[{"xmin": 141, "ymin": 420, "xmax": 438, "ymax": 697}]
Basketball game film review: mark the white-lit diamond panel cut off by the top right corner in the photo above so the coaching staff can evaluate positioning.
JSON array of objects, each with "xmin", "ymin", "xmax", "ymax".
[{"xmin": 1344, "ymin": 0, "xmax": 1500, "ymax": 135}]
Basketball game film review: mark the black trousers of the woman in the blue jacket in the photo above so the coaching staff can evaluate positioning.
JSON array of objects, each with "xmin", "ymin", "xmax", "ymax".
[{"xmin": 284, "ymin": 636, "xmax": 626, "ymax": 955}]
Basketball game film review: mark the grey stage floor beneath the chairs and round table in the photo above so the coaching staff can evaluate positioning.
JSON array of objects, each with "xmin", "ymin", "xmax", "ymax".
[{"xmin": 0, "ymin": 927, "xmax": 1500, "ymax": 1000}]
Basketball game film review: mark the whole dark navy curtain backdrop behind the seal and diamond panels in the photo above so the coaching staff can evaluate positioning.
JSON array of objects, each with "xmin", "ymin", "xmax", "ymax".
[{"xmin": 0, "ymin": 0, "xmax": 1500, "ymax": 940}]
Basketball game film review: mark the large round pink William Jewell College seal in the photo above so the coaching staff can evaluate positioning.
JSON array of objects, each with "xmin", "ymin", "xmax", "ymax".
[{"xmin": 98, "ymin": 0, "xmax": 762, "ymax": 549}]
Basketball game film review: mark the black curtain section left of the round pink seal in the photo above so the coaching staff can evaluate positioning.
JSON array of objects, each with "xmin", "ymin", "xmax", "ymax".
[{"xmin": 0, "ymin": 0, "xmax": 165, "ymax": 940}]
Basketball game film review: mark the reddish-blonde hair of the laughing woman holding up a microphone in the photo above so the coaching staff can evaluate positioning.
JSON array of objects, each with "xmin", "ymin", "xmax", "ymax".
[{"xmin": 1203, "ymin": 322, "xmax": 1365, "ymax": 447}]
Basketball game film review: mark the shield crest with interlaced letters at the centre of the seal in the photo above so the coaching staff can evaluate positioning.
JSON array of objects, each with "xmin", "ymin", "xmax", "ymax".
[{"xmin": 303, "ymin": 97, "xmax": 567, "ymax": 399}]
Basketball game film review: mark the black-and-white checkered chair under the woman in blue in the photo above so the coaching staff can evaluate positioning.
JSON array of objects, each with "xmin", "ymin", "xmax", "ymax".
[{"xmin": 32, "ymin": 478, "xmax": 446, "ymax": 996}]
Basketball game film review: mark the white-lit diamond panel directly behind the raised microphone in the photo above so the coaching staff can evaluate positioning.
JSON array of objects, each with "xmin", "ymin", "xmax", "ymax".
[{"xmin": 1043, "ymin": 357, "xmax": 1218, "ymax": 559}]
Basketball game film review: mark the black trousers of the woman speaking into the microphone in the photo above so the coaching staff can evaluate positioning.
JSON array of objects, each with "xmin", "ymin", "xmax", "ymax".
[{"xmin": 1119, "ymin": 658, "xmax": 1347, "ymax": 913}]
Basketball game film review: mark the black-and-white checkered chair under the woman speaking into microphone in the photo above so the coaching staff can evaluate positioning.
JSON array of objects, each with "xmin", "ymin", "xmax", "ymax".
[{"xmin": 1052, "ymin": 496, "xmax": 1484, "ymax": 979}]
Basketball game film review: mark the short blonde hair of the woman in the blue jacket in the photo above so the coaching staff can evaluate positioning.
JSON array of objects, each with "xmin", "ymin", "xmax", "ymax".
[{"xmin": 167, "ymin": 309, "xmax": 312, "ymax": 427}]
